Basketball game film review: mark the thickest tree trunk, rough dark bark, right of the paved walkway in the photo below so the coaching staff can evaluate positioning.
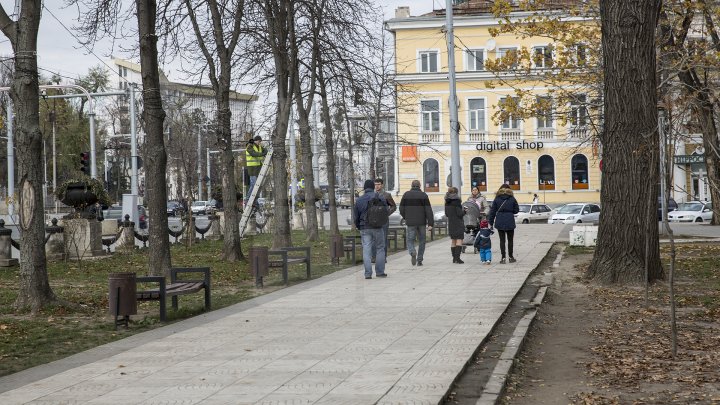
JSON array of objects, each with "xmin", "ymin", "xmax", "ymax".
[{"xmin": 588, "ymin": 0, "xmax": 663, "ymax": 283}]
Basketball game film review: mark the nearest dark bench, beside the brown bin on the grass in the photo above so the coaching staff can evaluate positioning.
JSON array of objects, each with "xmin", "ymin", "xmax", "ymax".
[{"xmin": 135, "ymin": 267, "xmax": 210, "ymax": 322}]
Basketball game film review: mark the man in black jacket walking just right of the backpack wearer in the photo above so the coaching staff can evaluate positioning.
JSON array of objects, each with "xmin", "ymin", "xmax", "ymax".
[{"xmin": 400, "ymin": 180, "xmax": 435, "ymax": 266}]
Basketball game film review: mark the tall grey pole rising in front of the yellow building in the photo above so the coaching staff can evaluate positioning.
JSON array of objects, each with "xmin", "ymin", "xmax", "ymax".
[{"xmin": 445, "ymin": 0, "xmax": 462, "ymax": 200}]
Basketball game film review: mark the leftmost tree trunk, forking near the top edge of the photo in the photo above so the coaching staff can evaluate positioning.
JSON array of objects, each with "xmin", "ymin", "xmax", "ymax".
[{"xmin": 0, "ymin": 0, "xmax": 57, "ymax": 313}]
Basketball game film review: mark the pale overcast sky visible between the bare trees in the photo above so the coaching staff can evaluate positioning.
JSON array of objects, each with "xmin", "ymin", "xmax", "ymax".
[{"xmin": 0, "ymin": 0, "xmax": 436, "ymax": 81}]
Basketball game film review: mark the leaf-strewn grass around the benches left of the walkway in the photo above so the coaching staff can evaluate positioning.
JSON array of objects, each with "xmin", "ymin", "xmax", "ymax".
[{"xmin": 0, "ymin": 227, "xmax": 414, "ymax": 376}]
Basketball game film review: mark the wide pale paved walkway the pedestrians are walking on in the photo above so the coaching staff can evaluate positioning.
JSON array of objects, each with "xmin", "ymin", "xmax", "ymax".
[{"xmin": 0, "ymin": 224, "xmax": 563, "ymax": 404}]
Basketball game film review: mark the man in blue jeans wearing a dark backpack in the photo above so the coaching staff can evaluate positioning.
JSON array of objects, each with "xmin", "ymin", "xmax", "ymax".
[{"xmin": 353, "ymin": 180, "xmax": 387, "ymax": 279}]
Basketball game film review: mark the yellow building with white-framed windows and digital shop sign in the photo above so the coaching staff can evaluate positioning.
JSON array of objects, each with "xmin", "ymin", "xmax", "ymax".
[{"xmin": 386, "ymin": 1, "xmax": 600, "ymax": 204}]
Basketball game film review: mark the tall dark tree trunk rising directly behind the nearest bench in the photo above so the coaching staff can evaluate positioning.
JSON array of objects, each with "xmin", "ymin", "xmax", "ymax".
[{"xmin": 135, "ymin": 0, "xmax": 171, "ymax": 276}]
